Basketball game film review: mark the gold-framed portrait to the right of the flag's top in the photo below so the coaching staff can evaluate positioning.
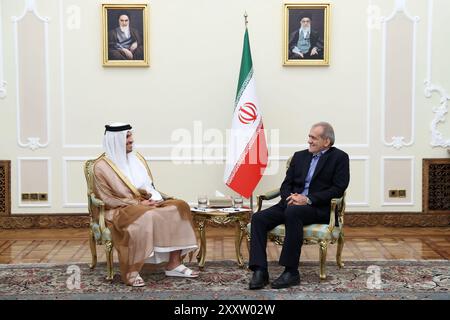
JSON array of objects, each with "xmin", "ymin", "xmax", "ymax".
[{"xmin": 283, "ymin": 3, "xmax": 330, "ymax": 66}]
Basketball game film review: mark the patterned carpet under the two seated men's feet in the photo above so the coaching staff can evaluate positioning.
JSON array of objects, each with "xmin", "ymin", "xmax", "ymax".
[{"xmin": 0, "ymin": 260, "xmax": 450, "ymax": 300}]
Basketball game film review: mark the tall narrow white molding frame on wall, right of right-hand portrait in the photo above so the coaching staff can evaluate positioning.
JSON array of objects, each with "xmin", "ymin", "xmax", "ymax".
[{"xmin": 381, "ymin": 0, "xmax": 420, "ymax": 149}]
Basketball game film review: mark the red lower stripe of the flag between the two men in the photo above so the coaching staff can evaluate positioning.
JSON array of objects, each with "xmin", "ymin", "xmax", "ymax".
[{"xmin": 227, "ymin": 124, "xmax": 268, "ymax": 198}]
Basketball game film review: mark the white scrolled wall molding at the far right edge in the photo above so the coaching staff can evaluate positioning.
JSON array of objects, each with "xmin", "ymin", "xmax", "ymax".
[{"xmin": 424, "ymin": 0, "xmax": 450, "ymax": 149}]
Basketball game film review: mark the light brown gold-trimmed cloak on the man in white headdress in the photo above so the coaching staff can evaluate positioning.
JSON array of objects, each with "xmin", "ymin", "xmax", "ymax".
[{"xmin": 94, "ymin": 156, "xmax": 197, "ymax": 284}]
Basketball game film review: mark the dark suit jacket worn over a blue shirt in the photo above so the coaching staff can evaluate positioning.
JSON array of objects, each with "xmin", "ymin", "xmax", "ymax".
[{"xmin": 279, "ymin": 147, "xmax": 350, "ymax": 217}]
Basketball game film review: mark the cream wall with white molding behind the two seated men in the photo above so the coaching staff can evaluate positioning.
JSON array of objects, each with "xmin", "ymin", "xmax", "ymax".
[{"xmin": 0, "ymin": 0, "xmax": 450, "ymax": 213}]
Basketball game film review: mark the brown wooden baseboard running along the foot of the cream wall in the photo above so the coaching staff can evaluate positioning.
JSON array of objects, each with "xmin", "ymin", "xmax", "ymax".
[{"xmin": 0, "ymin": 212, "xmax": 450, "ymax": 229}]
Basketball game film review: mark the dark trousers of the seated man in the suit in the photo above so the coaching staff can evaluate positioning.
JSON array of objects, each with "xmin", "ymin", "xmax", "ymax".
[{"xmin": 249, "ymin": 204, "xmax": 329, "ymax": 270}]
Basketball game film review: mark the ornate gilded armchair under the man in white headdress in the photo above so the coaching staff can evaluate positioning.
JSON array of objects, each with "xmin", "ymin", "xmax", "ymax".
[{"xmin": 84, "ymin": 153, "xmax": 172, "ymax": 280}]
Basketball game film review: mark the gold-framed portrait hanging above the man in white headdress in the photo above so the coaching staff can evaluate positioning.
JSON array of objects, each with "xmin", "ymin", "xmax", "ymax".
[{"xmin": 102, "ymin": 4, "xmax": 149, "ymax": 67}]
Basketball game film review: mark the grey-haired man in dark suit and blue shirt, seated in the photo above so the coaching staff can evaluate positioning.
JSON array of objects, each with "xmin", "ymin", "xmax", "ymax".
[{"xmin": 249, "ymin": 122, "xmax": 350, "ymax": 289}]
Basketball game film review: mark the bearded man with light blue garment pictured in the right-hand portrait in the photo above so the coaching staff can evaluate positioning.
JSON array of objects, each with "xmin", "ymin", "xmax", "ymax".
[{"xmin": 289, "ymin": 15, "xmax": 323, "ymax": 59}]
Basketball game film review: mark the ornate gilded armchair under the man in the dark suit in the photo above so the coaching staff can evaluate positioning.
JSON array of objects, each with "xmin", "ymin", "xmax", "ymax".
[{"xmin": 247, "ymin": 158, "xmax": 345, "ymax": 280}]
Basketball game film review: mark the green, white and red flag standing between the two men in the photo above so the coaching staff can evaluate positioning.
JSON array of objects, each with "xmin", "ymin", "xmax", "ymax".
[{"xmin": 224, "ymin": 28, "xmax": 268, "ymax": 198}]
